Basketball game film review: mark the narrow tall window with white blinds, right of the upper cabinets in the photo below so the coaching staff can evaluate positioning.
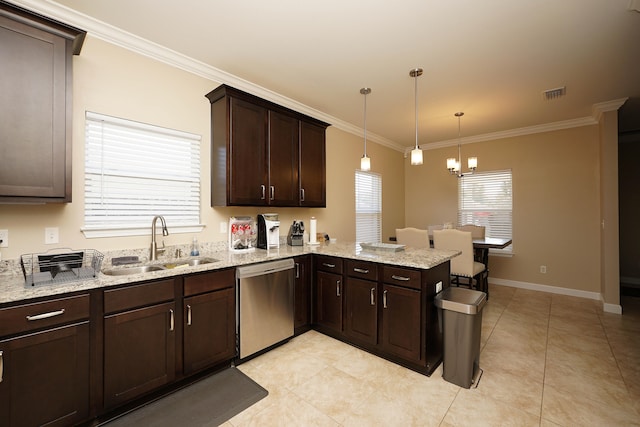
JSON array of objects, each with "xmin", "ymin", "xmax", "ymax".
[{"xmin": 356, "ymin": 170, "xmax": 382, "ymax": 243}]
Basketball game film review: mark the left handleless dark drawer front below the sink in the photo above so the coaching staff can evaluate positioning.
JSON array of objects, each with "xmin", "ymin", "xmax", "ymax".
[{"xmin": 104, "ymin": 279, "xmax": 175, "ymax": 314}]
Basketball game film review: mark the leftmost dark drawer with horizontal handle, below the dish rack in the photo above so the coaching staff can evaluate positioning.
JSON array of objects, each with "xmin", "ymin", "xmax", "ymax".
[{"xmin": 0, "ymin": 294, "xmax": 89, "ymax": 336}]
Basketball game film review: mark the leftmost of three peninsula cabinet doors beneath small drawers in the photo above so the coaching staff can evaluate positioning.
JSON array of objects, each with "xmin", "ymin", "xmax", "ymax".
[{"xmin": 316, "ymin": 271, "xmax": 342, "ymax": 333}]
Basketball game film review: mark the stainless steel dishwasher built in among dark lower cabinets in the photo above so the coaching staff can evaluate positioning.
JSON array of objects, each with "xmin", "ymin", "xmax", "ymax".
[{"xmin": 236, "ymin": 258, "xmax": 294, "ymax": 359}]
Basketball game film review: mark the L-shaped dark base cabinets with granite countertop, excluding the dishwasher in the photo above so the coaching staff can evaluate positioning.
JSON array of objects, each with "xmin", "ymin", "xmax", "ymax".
[{"xmin": 0, "ymin": 243, "xmax": 457, "ymax": 425}]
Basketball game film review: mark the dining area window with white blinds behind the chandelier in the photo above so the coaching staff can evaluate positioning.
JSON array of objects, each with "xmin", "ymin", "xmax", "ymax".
[{"xmin": 458, "ymin": 170, "xmax": 513, "ymax": 253}]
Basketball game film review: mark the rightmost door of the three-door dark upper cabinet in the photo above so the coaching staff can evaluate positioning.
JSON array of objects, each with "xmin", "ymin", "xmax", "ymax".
[{"xmin": 300, "ymin": 121, "xmax": 327, "ymax": 208}]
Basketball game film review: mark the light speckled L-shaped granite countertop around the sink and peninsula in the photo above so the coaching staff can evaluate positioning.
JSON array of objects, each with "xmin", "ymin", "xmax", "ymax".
[{"xmin": 0, "ymin": 242, "xmax": 459, "ymax": 304}]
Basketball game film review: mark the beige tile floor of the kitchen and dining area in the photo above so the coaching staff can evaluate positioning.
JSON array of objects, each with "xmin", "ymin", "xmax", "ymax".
[{"xmin": 224, "ymin": 286, "xmax": 640, "ymax": 427}]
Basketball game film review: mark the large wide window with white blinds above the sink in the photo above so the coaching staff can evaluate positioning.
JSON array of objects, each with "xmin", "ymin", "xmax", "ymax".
[{"xmin": 82, "ymin": 112, "xmax": 203, "ymax": 237}]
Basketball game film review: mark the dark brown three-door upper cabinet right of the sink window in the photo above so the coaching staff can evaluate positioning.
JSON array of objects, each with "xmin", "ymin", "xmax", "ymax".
[{"xmin": 206, "ymin": 85, "xmax": 329, "ymax": 207}]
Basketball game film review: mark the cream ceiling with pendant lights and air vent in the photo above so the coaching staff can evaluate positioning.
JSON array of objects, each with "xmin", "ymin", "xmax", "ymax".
[{"xmin": 12, "ymin": 0, "xmax": 640, "ymax": 150}]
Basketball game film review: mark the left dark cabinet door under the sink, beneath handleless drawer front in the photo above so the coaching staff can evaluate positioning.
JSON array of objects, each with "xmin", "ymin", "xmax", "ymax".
[{"xmin": 104, "ymin": 302, "xmax": 176, "ymax": 408}]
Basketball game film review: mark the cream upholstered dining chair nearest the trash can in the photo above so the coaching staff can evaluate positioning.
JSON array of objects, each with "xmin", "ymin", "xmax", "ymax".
[{"xmin": 433, "ymin": 229, "xmax": 489, "ymax": 297}]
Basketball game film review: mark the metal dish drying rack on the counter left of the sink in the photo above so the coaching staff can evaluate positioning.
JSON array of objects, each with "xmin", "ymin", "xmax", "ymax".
[{"xmin": 20, "ymin": 248, "xmax": 104, "ymax": 286}]
